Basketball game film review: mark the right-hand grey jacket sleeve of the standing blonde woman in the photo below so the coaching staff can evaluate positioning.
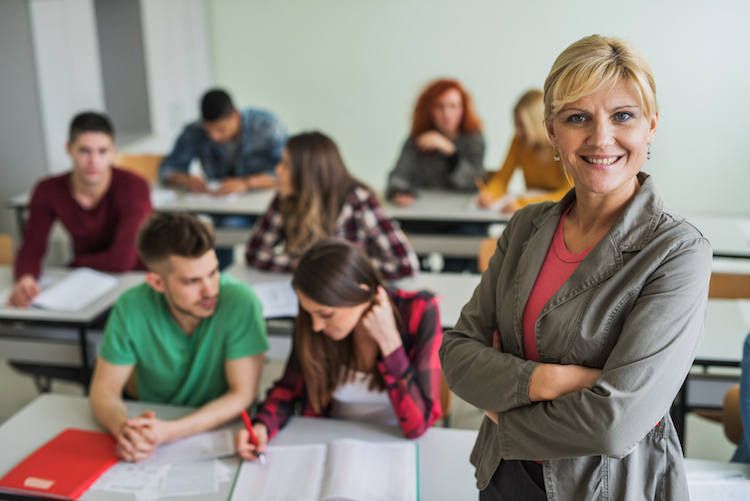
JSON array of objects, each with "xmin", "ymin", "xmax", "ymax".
[{"xmin": 498, "ymin": 238, "xmax": 712, "ymax": 460}]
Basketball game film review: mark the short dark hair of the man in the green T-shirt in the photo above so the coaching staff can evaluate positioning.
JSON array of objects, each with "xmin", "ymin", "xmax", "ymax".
[{"xmin": 136, "ymin": 212, "xmax": 215, "ymax": 271}]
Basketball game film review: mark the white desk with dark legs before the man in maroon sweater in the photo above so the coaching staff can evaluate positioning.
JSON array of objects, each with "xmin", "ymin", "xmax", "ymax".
[{"xmin": 0, "ymin": 266, "xmax": 145, "ymax": 386}]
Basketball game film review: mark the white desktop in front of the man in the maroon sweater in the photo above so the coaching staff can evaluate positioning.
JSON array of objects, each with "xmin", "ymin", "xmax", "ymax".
[{"xmin": 0, "ymin": 266, "xmax": 146, "ymax": 326}]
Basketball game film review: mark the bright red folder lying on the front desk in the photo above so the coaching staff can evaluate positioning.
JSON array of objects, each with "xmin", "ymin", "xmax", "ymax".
[{"xmin": 0, "ymin": 428, "xmax": 117, "ymax": 499}]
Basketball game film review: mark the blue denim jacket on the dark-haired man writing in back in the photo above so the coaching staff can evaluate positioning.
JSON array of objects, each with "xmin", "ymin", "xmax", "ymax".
[{"xmin": 159, "ymin": 108, "xmax": 287, "ymax": 182}]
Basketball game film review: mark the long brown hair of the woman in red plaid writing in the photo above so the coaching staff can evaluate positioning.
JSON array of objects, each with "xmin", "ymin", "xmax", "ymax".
[{"xmin": 292, "ymin": 238, "xmax": 390, "ymax": 412}]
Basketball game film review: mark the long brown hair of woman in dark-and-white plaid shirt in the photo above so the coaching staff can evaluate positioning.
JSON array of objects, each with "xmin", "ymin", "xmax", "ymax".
[{"xmin": 279, "ymin": 132, "xmax": 372, "ymax": 253}]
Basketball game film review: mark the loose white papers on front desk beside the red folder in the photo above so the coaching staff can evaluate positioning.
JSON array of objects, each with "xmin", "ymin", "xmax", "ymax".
[{"xmin": 91, "ymin": 430, "xmax": 234, "ymax": 501}]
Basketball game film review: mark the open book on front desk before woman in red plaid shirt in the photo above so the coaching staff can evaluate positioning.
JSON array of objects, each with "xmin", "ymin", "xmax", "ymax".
[{"xmin": 230, "ymin": 439, "xmax": 419, "ymax": 501}]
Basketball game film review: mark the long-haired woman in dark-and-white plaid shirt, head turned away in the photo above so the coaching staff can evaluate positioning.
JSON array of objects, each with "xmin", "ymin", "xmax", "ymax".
[{"xmin": 247, "ymin": 132, "xmax": 419, "ymax": 279}]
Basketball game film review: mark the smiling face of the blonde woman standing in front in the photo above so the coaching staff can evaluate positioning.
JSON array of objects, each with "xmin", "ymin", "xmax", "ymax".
[{"xmin": 546, "ymin": 81, "xmax": 659, "ymax": 197}]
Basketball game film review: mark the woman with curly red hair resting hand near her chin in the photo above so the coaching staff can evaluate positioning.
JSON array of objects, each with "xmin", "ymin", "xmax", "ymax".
[{"xmin": 387, "ymin": 79, "xmax": 484, "ymax": 207}]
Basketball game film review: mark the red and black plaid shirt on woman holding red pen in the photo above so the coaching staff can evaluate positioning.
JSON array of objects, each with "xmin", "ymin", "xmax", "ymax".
[{"xmin": 253, "ymin": 290, "xmax": 443, "ymax": 438}]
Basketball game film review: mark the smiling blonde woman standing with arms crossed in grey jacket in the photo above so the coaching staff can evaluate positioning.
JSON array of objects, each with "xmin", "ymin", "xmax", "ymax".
[{"xmin": 440, "ymin": 35, "xmax": 712, "ymax": 501}]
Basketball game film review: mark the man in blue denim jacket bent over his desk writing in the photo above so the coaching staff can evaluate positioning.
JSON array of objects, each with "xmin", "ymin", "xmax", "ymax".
[{"xmin": 159, "ymin": 89, "xmax": 287, "ymax": 195}]
